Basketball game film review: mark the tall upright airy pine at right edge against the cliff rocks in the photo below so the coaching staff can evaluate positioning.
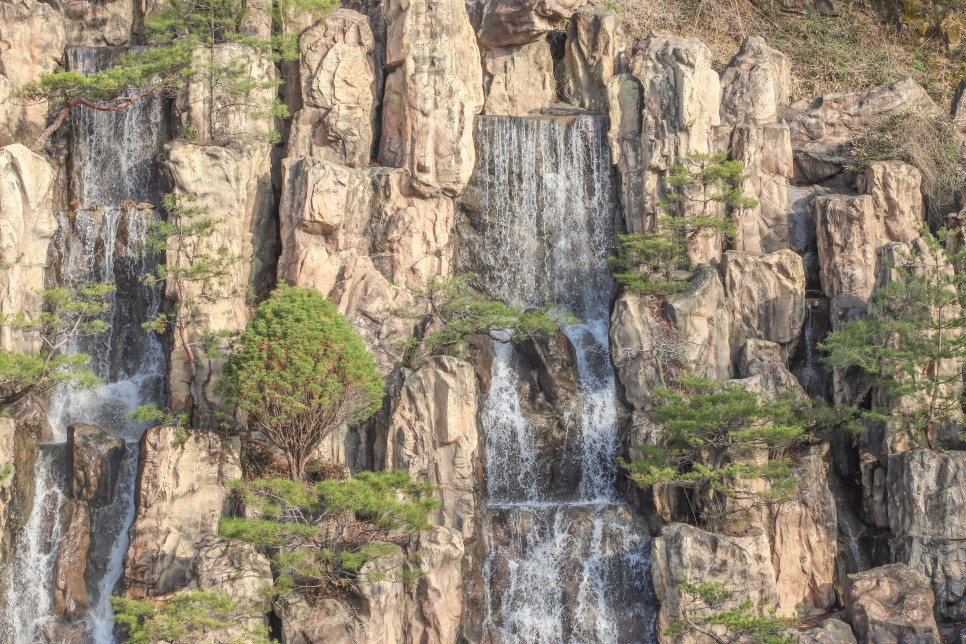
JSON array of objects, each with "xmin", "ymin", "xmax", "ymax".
[{"xmin": 820, "ymin": 229, "xmax": 966, "ymax": 449}]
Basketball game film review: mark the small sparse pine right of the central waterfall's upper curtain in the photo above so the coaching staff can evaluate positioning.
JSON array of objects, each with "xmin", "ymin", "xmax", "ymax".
[{"xmin": 611, "ymin": 153, "xmax": 758, "ymax": 295}]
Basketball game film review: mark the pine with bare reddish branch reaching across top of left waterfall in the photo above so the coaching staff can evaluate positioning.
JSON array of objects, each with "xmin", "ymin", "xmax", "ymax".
[{"xmin": 16, "ymin": 0, "xmax": 337, "ymax": 150}]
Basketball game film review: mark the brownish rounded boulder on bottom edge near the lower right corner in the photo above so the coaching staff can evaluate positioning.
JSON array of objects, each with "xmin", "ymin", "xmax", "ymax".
[{"xmin": 845, "ymin": 564, "xmax": 940, "ymax": 644}]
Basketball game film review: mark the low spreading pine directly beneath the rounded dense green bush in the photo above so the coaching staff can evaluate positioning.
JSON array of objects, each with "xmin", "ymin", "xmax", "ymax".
[{"xmin": 219, "ymin": 470, "xmax": 439, "ymax": 594}]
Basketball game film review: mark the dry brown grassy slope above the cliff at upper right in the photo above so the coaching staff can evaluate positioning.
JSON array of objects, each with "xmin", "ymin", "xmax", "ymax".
[{"xmin": 592, "ymin": 0, "xmax": 966, "ymax": 104}]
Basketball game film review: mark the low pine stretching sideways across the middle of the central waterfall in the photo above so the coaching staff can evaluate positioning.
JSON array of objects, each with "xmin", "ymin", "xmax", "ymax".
[{"xmin": 397, "ymin": 274, "xmax": 577, "ymax": 363}]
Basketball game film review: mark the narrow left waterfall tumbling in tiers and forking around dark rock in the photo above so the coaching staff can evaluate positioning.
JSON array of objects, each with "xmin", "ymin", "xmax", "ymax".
[{"xmin": 3, "ymin": 49, "xmax": 166, "ymax": 644}]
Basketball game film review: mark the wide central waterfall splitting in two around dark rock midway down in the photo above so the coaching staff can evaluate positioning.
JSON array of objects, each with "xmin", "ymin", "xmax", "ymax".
[{"xmin": 468, "ymin": 116, "xmax": 655, "ymax": 643}]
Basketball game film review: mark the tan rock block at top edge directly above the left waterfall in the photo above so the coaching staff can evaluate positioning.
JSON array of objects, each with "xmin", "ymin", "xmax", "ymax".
[{"xmin": 62, "ymin": 0, "xmax": 140, "ymax": 47}]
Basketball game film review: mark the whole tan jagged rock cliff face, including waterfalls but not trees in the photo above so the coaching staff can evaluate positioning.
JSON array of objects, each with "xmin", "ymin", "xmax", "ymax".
[{"xmin": 0, "ymin": 0, "xmax": 966, "ymax": 644}]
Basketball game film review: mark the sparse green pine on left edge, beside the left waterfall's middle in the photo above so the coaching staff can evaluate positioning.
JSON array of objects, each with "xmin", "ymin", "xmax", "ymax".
[{"xmin": 0, "ymin": 283, "xmax": 114, "ymax": 405}]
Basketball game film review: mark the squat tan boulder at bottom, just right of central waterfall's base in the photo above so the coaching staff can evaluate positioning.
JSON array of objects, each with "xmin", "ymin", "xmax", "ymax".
[{"xmin": 651, "ymin": 523, "xmax": 778, "ymax": 644}]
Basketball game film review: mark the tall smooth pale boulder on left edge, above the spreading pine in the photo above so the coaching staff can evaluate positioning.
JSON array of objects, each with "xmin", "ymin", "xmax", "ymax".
[{"xmin": 0, "ymin": 143, "xmax": 57, "ymax": 351}]
